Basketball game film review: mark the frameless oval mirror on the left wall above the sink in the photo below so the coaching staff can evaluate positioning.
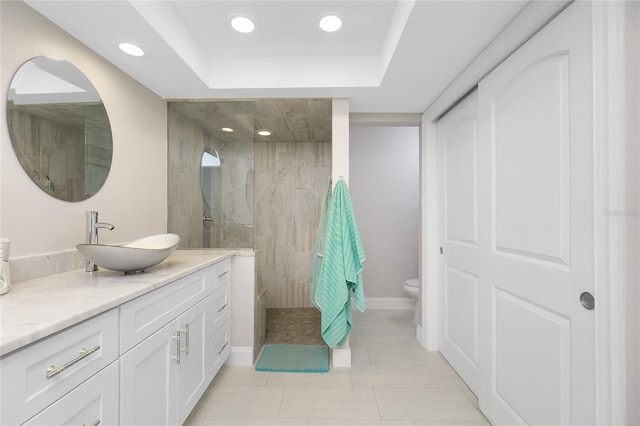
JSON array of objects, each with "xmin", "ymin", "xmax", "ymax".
[{"xmin": 7, "ymin": 56, "xmax": 113, "ymax": 201}]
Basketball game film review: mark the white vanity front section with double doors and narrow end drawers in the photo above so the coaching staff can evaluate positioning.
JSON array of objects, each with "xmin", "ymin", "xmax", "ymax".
[{"xmin": 120, "ymin": 259, "xmax": 230, "ymax": 426}]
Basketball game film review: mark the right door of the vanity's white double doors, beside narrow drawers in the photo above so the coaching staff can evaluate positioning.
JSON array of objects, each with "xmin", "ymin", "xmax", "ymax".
[{"xmin": 177, "ymin": 296, "xmax": 211, "ymax": 424}]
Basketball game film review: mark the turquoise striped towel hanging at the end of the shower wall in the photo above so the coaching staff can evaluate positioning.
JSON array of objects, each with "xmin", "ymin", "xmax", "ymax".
[{"xmin": 313, "ymin": 179, "xmax": 365, "ymax": 348}]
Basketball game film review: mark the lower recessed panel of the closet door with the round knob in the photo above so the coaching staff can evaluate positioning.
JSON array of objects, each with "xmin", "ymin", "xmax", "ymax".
[{"xmin": 493, "ymin": 289, "xmax": 571, "ymax": 425}]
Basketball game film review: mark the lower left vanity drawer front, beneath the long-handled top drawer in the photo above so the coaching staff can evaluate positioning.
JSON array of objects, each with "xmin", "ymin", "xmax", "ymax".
[{"xmin": 24, "ymin": 361, "xmax": 118, "ymax": 426}]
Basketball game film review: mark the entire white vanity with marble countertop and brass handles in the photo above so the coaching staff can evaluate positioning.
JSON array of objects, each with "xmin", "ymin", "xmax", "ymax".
[{"xmin": 0, "ymin": 251, "xmax": 233, "ymax": 426}]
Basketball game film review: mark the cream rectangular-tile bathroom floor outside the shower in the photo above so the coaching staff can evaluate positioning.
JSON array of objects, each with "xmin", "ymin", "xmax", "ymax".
[{"xmin": 185, "ymin": 309, "xmax": 489, "ymax": 426}]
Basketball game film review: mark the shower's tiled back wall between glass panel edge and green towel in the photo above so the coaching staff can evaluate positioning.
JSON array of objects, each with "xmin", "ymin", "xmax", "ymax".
[{"xmin": 254, "ymin": 140, "xmax": 331, "ymax": 308}]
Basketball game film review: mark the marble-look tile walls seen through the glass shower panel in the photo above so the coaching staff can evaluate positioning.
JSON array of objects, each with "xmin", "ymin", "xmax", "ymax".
[{"xmin": 167, "ymin": 103, "xmax": 253, "ymax": 248}]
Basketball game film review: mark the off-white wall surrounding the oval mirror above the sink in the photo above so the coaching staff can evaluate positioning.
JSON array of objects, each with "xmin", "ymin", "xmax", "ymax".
[{"xmin": 0, "ymin": 1, "xmax": 167, "ymax": 258}]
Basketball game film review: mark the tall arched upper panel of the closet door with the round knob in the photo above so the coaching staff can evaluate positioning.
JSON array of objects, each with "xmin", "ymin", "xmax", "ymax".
[{"xmin": 490, "ymin": 53, "xmax": 571, "ymax": 265}]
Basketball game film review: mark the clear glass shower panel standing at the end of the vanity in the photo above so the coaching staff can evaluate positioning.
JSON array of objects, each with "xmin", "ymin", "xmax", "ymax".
[{"xmin": 168, "ymin": 101, "xmax": 254, "ymax": 249}]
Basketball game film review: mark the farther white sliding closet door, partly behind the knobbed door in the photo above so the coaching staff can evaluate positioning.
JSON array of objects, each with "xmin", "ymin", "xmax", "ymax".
[{"xmin": 438, "ymin": 92, "xmax": 479, "ymax": 394}]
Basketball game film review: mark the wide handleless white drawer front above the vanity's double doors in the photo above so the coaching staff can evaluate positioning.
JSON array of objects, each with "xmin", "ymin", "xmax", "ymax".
[{"xmin": 120, "ymin": 267, "xmax": 213, "ymax": 354}]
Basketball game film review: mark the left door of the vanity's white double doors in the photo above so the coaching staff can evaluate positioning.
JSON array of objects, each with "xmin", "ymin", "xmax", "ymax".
[{"xmin": 120, "ymin": 321, "xmax": 181, "ymax": 426}]
